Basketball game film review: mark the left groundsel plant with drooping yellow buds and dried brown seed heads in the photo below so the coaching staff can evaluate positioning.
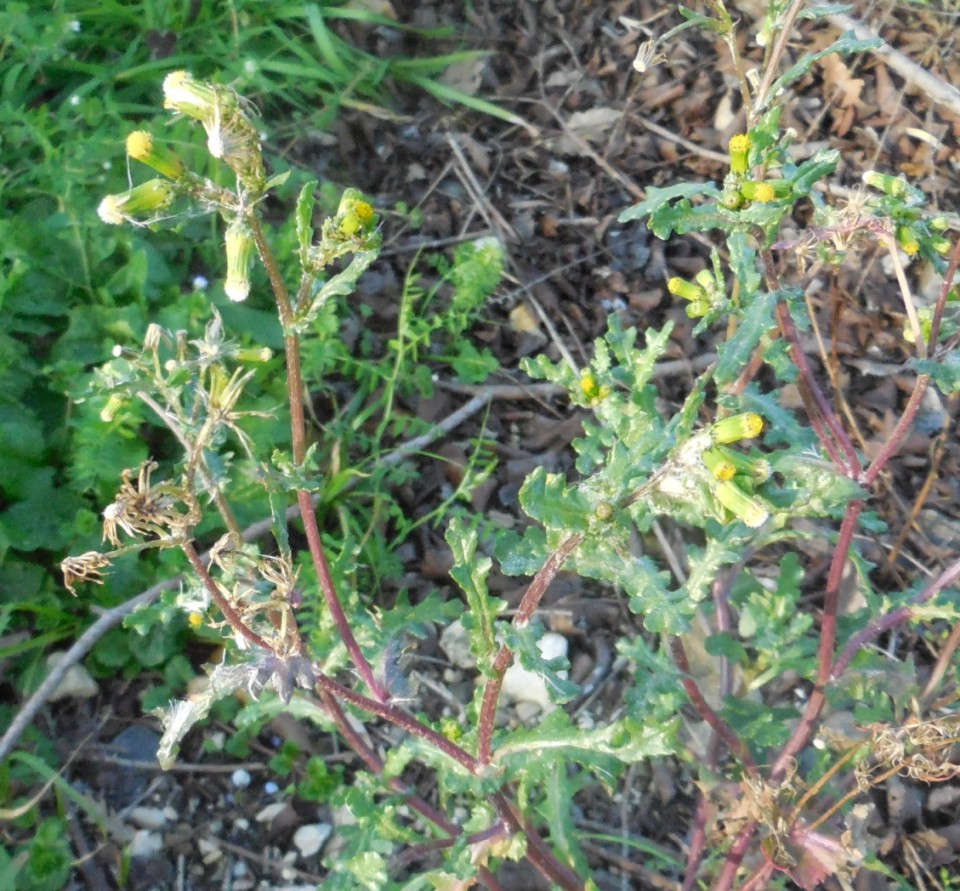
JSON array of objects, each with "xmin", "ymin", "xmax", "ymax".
[{"xmin": 75, "ymin": 72, "xmax": 667, "ymax": 889}]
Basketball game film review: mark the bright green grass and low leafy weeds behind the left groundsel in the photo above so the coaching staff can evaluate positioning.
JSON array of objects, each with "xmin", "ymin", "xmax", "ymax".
[{"xmin": 0, "ymin": 0, "xmax": 509, "ymax": 888}]
